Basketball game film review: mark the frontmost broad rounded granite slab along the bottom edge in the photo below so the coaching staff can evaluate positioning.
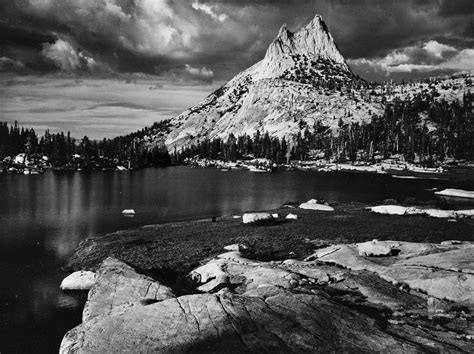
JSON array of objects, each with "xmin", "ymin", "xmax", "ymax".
[{"xmin": 60, "ymin": 289, "xmax": 422, "ymax": 353}]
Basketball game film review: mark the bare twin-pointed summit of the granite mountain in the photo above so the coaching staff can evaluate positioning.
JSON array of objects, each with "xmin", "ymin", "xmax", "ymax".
[{"xmin": 257, "ymin": 15, "xmax": 350, "ymax": 78}]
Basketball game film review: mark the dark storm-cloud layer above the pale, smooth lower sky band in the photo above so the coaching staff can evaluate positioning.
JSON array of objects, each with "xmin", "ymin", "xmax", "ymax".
[{"xmin": 0, "ymin": 0, "xmax": 474, "ymax": 80}]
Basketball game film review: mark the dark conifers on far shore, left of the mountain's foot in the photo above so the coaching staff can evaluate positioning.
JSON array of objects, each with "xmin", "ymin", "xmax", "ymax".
[{"xmin": 0, "ymin": 121, "xmax": 171, "ymax": 169}]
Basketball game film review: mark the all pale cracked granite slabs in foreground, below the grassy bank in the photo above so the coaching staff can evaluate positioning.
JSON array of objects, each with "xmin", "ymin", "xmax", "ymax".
[{"xmin": 60, "ymin": 241, "xmax": 474, "ymax": 353}]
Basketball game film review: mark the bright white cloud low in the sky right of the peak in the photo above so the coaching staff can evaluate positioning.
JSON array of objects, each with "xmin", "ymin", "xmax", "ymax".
[{"xmin": 349, "ymin": 40, "xmax": 474, "ymax": 75}]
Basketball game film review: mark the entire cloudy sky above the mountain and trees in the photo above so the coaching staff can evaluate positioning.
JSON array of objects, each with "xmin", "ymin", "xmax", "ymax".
[{"xmin": 0, "ymin": 0, "xmax": 474, "ymax": 138}]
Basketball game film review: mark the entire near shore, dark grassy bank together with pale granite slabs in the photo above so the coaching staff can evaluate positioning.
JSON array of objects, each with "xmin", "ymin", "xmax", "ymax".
[{"xmin": 60, "ymin": 203, "xmax": 474, "ymax": 353}]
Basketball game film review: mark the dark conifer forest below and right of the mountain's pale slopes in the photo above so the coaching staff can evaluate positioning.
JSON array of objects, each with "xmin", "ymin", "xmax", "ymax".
[{"xmin": 172, "ymin": 92, "xmax": 474, "ymax": 165}]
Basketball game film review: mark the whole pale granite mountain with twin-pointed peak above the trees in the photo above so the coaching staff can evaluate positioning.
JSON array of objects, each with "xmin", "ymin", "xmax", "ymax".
[{"xmin": 143, "ymin": 15, "xmax": 470, "ymax": 151}]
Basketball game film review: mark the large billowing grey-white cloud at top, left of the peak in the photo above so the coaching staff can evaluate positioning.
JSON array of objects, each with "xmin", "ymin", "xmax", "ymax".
[{"xmin": 24, "ymin": 0, "xmax": 262, "ymax": 71}]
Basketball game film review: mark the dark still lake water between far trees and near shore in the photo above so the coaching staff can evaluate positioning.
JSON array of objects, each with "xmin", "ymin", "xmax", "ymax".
[{"xmin": 0, "ymin": 167, "xmax": 474, "ymax": 353}]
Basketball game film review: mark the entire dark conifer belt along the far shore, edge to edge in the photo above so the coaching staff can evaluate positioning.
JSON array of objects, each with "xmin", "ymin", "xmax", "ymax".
[{"xmin": 0, "ymin": 91, "xmax": 474, "ymax": 169}]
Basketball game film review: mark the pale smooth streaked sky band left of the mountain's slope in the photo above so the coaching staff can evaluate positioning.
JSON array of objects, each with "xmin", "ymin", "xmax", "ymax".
[{"xmin": 0, "ymin": 75, "xmax": 218, "ymax": 139}]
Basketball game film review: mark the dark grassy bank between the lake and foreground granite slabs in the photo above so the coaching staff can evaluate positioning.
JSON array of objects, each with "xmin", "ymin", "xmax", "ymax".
[{"xmin": 65, "ymin": 203, "xmax": 474, "ymax": 274}]
